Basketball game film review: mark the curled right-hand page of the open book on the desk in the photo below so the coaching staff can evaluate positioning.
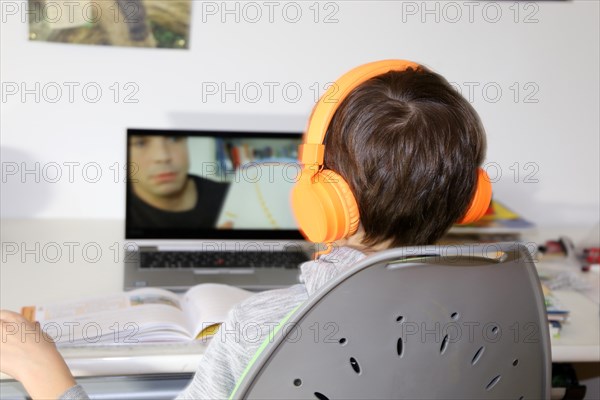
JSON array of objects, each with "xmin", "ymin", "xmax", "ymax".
[{"xmin": 182, "ymin": 283, "xmax": 254, "ymax": 338}]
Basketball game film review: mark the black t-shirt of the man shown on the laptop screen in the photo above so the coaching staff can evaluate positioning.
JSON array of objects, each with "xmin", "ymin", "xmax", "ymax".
[{"xmin": 127, "ymin": 175, "xmax": 229, "ymax": 229}]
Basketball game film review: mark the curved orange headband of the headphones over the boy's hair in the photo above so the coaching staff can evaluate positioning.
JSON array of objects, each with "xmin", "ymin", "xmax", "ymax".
[{"xmin": 299, "ymin": 60, "xmax": 419, "ymax": 165}]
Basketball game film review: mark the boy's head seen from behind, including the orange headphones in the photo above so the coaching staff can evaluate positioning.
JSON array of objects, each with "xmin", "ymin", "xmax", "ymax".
[{"xmin": 292, "ymin": 60, "xmax": 492, "ymax": 249}]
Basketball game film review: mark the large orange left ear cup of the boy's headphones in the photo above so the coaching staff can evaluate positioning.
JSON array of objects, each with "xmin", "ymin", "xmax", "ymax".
[{"xmin": 292, "ymin": 170, "xmax": 359, "ymax": 243}]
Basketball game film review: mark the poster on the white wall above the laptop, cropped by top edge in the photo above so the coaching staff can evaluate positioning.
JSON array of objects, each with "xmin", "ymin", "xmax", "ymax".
[{"xmin": 28, "ymin": 0, "xmax": 192, "ymax": 49}]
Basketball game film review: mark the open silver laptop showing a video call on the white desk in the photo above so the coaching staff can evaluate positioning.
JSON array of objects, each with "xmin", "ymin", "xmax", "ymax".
[{"xmin": 124, "ymin": 129, "xmax": 317, "ymax": 291}]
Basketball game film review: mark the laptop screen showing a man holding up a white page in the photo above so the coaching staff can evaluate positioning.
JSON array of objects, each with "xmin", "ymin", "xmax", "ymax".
[{"xmin": 125, "ymin": 129, "xmax": 302, "ymax": 239}]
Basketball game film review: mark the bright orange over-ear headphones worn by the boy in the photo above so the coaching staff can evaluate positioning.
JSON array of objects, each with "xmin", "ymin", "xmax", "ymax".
[{"xmin": 292, "ymin": 60, "xmax": 492, "ymax": 243}]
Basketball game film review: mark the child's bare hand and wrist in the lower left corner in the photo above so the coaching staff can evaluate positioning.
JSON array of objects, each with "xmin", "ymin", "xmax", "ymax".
[{"xmin": 0, "ymin": 310, "xmax": 75, "ymax": 399}]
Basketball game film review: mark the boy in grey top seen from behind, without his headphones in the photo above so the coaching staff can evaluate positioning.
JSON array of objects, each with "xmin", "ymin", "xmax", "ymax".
[{"xmin": 0, "ymin": 60, "xmax": 485, "ymax": 399}]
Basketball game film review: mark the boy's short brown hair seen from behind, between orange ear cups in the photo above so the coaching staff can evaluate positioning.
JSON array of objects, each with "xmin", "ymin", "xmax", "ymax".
[{"xmin": 324, "ymin": 67, "xmax": 486, "ymax": 246}]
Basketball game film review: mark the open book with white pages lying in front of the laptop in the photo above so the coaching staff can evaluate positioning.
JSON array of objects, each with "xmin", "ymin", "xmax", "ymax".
[{"xmin": 21, "ymin": 283, "xmax": 253, "ymax": 346}]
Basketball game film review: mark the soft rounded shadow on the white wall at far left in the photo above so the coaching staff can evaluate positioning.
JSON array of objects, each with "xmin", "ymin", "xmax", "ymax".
[{"xmin": 0, "ymin": 147, "xmax": 56, "ymax": 218}]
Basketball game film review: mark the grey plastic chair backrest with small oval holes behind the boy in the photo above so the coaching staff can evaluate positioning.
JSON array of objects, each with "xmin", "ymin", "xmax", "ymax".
[{"xmin": 232, "ymin": 243, "xmax": 551, "ymax": 400}]
